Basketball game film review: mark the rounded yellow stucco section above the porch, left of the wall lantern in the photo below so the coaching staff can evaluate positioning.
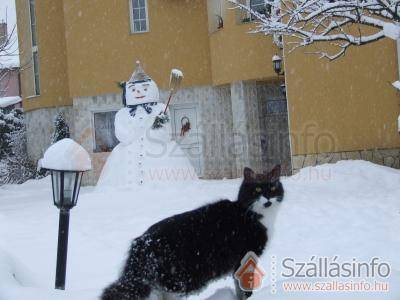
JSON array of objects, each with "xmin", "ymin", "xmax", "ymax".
[{"xmin": 210, "ymin": 4, "xmax": 280, "ymax": 85}]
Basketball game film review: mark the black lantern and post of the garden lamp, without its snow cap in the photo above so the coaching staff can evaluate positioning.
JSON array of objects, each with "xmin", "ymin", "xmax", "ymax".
[{"xmin": 50, "ymin": 170, "xmax": 83, "ymax": 290}]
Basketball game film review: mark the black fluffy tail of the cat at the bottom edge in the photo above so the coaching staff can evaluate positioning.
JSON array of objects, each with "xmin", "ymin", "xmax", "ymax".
[{"xmin": 100, "ymin": 281, "xmax": 151, "ymax": 300}]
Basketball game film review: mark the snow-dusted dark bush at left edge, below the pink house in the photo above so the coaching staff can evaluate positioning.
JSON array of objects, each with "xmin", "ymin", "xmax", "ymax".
[{"xmin": 0, "ymin": 109, "xmax": 35, "ymax": 185}]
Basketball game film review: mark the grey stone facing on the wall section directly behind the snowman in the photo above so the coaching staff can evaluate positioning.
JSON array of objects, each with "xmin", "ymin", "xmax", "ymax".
[{"xmin": 73, "ymin": 86, "xmax": 235, "ymax": 185}]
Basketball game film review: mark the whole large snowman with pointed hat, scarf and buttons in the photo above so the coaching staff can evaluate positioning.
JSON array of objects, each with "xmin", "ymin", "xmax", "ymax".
[{"xmin": 97, "ymin": 62, "xmax": 197, "ymax": 187}]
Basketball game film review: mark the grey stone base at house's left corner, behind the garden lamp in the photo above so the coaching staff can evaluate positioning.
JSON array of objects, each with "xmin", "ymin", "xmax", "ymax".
[{"xmin": 24, "ymin": 105, "xmax": 74, "ymax": 163}]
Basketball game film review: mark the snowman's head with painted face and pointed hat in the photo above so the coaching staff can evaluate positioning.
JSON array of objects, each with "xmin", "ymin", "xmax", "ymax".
[{"xmin": 123, "ymin": 61, "xmax": 160, "ymax": 106}]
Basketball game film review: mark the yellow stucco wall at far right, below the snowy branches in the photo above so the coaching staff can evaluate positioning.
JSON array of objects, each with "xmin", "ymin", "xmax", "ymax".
[{"xmin": 286, "ymin": 39, "xmax": 400, "ymax": 155}]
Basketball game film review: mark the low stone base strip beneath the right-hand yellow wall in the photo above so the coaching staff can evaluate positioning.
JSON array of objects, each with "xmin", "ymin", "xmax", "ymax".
[{"xmin": 292, "ymin": 149, "xmax": 400, "ymax": 173}]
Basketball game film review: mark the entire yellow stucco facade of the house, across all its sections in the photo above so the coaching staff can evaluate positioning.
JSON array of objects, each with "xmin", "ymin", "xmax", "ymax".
[{"xmin": 16, "ymin": 0, "xmax": 400, "ymax": 155}]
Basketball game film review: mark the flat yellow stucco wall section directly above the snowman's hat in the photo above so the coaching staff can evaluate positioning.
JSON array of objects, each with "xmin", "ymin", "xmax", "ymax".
[{"xmin": 64, "ymin": 0, "xmax": 211, "ymax": 96}]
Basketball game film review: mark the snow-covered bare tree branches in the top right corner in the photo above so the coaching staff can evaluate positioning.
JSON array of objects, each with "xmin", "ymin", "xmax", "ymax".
[{"xmin": 229, "ymin": 0, "xmax": 400, "ymax": 60}]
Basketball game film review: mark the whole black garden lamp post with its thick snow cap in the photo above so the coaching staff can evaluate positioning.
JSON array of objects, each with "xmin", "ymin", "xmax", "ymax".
[{"xmin": 40, "ymin": 138, "xmax": 91, "ymax": 290}]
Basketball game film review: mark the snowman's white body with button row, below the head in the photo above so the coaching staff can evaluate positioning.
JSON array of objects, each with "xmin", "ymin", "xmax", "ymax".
[{"xmin": 98, "ymin": 103, "xmax": 197, "ymax": 186}]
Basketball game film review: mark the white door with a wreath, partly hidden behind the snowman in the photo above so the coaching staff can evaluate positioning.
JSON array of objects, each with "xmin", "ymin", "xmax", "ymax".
[{"xmin": 170, "ymin": 105, "xmax": 202, "ymax": 176}]
